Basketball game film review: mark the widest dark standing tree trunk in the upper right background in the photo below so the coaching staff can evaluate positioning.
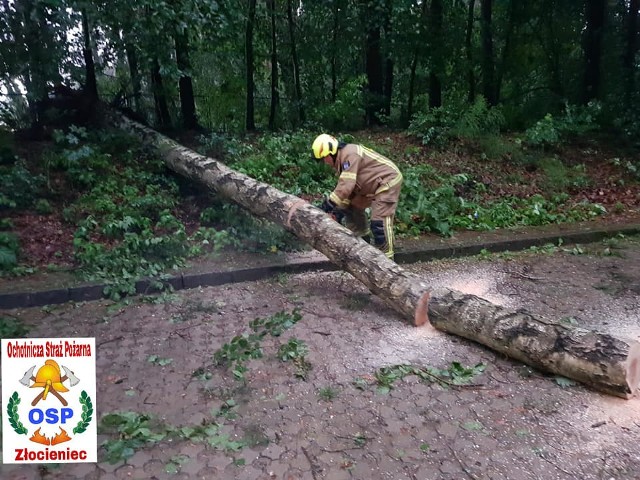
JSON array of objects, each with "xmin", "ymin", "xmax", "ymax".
[{"xmin": 582, "ymin": 0, "xmax": 606, "ymax": 105}]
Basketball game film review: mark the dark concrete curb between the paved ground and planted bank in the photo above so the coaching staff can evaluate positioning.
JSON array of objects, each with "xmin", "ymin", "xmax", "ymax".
[{"xmin": 0, "ymin": 225, "xmax": 640, "ymax": 309}]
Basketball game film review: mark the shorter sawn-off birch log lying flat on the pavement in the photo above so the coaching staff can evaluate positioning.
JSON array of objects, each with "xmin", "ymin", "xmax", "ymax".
[{"xmin": 429, "ymin": 288, "xmax": 640, "ymax": 399}]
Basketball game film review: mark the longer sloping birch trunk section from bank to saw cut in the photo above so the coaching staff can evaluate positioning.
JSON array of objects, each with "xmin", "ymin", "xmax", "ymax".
[{"xmin": 111, "ymin": 114, "xmax": 429, "ymax": 326}]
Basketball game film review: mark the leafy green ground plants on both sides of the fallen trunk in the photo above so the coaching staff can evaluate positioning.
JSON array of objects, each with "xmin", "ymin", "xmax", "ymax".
[{"xmin": 0, "ymin": 124, "xmax": 616, "ymax": 292}]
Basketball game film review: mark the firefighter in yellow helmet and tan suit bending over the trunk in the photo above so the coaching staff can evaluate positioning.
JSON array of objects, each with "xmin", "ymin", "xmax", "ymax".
[{"xmin": 311, "ymin": 133, "xmax": 402, "ymax": 260}]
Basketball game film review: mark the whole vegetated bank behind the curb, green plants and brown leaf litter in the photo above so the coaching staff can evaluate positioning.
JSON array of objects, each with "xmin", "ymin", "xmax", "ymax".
[{"xmin": 0, "ymin": 108, "xmax": 638, "ymax": 299}]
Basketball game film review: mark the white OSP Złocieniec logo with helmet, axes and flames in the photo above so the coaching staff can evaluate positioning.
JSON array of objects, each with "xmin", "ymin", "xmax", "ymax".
[{"xmin": 2, "ymin": 338, "xmax": 97, "ymax": 463}]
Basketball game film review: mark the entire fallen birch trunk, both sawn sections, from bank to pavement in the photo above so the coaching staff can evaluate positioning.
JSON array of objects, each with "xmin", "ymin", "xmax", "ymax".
[{"xmin": 111, "ymin": 111, "xmax": 640, "ymax": 398}]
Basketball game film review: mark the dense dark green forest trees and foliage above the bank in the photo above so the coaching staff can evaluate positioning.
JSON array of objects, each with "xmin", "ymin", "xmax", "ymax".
[{"xmin": 0, "ymin": 0, "xmax": 640, "ymax": 139}]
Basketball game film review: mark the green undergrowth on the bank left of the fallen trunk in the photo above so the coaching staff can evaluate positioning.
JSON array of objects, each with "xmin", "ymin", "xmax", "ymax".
[{"xmin": 0, "ymin": 126, "xmax": 300, "ymax": 300}]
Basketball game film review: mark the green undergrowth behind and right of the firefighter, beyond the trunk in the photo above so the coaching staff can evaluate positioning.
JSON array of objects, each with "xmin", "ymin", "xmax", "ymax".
[{"xmin": 201, "ymin": 130, "xmax": 606, "ymax": 236}]
